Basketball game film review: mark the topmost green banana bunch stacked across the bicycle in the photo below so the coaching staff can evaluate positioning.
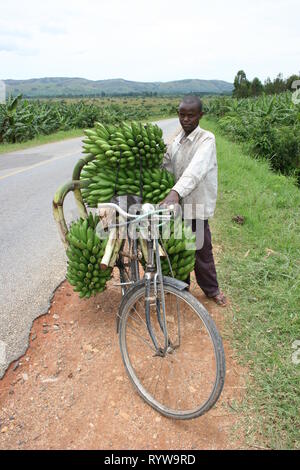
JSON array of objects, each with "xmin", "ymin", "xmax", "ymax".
[{"xmin": 83, "ymin": 122, "xmax": 166, "ymax": 168}]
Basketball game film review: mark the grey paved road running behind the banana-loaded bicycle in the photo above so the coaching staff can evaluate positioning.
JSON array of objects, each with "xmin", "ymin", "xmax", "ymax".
[{"xmin": 0, "ymin": 119, "xmax": 178, "ymax": 378}]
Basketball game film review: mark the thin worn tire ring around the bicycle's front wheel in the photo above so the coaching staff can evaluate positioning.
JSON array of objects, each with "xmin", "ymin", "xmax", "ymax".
[{"xmin": 119, "ymin": 285, "xmax": 225, "ymax": 420}]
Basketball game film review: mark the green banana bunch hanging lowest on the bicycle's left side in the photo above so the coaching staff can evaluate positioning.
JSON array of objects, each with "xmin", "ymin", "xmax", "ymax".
[{"xmin": 67, "ymin": 213, "xmax": 112, "ymax": 298}]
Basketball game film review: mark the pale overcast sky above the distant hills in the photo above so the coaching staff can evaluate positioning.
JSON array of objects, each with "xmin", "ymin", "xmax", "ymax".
[{"xmin": 0, "ymin": 0, "xmax": 300, "ymax": 82}]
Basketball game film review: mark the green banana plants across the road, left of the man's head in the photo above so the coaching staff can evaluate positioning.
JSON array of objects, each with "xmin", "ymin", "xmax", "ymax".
[{"xmin": 0, "ymin": 95, "xmax": 179, "ymax": 153}]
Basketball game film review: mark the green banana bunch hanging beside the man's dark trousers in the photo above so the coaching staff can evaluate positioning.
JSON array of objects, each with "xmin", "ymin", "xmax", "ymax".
[{"xmin": 161, "ymin": 221, "xmax": 196, "ymax": 281}]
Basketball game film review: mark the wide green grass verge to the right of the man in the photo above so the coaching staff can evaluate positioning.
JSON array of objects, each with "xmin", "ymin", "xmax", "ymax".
[{"xmin": 201, "ymin": 118, "xmax": 300, "ymax": 449}]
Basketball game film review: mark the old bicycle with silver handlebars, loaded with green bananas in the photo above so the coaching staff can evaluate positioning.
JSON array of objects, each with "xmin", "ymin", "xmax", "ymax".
[{"xmin": 98, "ymin": 195, "xmax": 225, "ymax": 419}]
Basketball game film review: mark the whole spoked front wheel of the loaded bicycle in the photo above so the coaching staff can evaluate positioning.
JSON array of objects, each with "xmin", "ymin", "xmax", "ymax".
[{"xmin": 119, "ymin": 285, "xmax": 225, "ymax": 419}]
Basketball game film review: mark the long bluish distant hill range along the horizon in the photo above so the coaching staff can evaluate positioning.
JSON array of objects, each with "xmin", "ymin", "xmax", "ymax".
[{"xmin": 4, "ymin": 77, "xmax": 233, "ymax": 98}]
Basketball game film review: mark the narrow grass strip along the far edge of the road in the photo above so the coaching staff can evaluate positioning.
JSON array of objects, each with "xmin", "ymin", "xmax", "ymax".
[{"xmin": 0, "ymin": 114, "xmax": 175, "ymax": 155}]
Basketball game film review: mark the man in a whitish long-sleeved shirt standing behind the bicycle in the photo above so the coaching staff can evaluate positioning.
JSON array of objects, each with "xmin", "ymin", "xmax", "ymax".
[{"xmin": 161, "ymin": 96, "xmax": 226, "ymax": 306}]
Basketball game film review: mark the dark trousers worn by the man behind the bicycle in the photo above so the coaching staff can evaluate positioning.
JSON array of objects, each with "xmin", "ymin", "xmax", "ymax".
[{"xmin": 186, "ymin": 219, "xmax": 220, "ymax": 297}]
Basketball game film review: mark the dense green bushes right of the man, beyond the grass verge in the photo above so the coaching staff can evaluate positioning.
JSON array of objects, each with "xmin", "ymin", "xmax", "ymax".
[{"xmin": 205, "ymin": 92, "xmax": 300, "ymax": 184}]
